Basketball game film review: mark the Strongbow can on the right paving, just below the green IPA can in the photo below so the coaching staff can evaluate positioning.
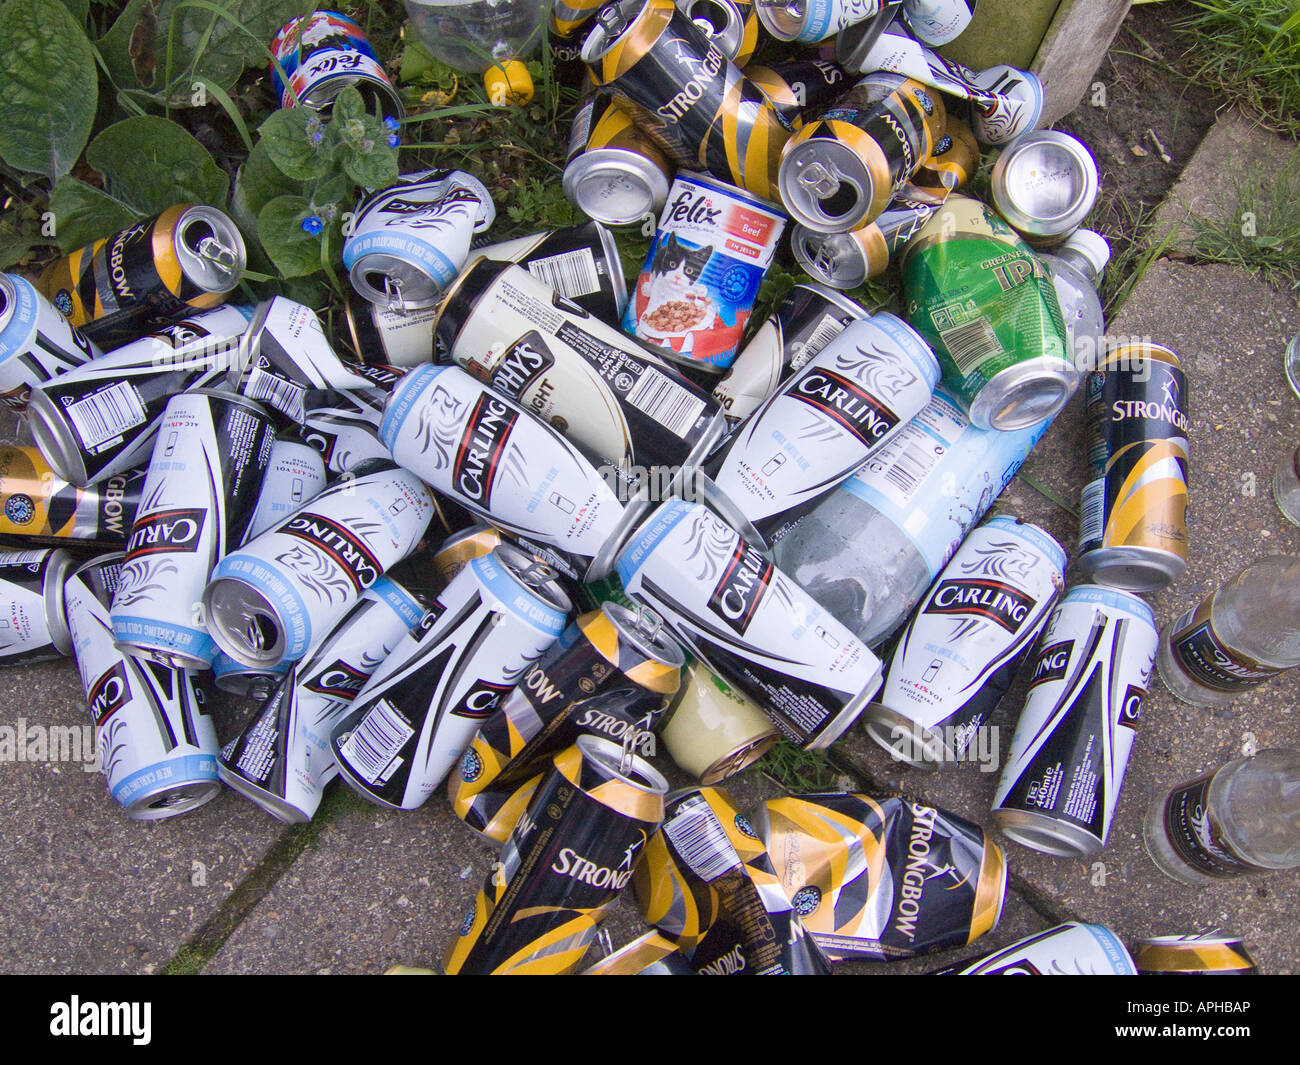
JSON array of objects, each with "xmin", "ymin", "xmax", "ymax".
[{"xmin": 1079, "ymin": 342, "xmax": 1190, "ymax": 592}]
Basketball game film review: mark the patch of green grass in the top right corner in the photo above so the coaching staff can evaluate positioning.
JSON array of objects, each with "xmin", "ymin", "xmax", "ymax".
[{"xmin": 1174, "ymin": 0, "xmax": 1300, "ymax": 138}]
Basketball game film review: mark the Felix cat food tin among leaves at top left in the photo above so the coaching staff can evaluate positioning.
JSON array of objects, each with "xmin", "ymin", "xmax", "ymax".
[{"xmin": 270, "ymin": 12, "xmax": 406, "ymax": 121}]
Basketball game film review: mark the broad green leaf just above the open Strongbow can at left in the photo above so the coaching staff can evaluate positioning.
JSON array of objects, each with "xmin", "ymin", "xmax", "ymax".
[{"xmin": 86, "ymin": 114, "xmax": 230, "ymax": 215}]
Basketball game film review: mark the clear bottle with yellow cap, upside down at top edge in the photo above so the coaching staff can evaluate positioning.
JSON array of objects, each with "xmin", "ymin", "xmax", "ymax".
[{"xmin": 403, "ymin": 0, "xmax": 547, "ymax": 104}]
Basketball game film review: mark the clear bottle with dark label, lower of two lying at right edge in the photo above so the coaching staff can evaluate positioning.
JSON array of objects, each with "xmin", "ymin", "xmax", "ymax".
[{"xmin": 1143, "ymin": 749, "xmax": 1300, "ymax": 884}]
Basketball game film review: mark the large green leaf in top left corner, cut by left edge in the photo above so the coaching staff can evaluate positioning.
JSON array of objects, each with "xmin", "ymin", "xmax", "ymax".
[{"xmin": 0, "ymin": 0, "xmax": 99, "ymax": 183}]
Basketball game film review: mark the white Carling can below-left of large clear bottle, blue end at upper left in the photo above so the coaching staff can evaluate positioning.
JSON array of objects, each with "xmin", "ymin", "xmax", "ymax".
[{"xmin": 618, "ymin": 499, "xmax": 880, "ymax": 749}]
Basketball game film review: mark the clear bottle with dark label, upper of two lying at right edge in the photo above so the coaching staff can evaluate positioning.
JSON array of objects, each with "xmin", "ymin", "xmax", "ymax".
[{"xmin": 1156, "ymin": 555, "xmax": 1300, "ymax": 706}]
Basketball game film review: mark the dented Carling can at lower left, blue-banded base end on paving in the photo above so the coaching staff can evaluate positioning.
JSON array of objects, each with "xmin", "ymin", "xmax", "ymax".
[{"xmin": 65, "ymin": 554, "xmax": 221, "ymax": 821}]
